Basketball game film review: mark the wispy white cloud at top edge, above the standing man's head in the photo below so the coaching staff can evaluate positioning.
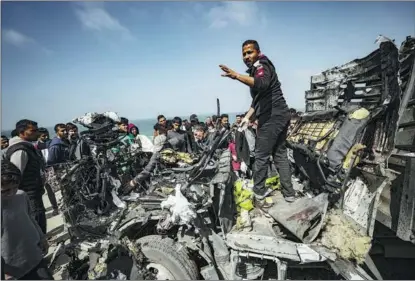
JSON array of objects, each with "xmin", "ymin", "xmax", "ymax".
[{"xmin": 207, "ymin": 1, "xmax": 266, "ymax": 28}]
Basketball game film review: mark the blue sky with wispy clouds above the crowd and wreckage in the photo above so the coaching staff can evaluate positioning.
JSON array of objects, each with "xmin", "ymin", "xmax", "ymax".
[{"xmin": 1, "ymin": 2, "xmax": 415, "ymax": 129}]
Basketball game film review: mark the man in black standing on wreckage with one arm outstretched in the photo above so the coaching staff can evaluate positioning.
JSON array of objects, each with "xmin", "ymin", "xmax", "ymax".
[{"xmin": 219, "ymin": 40, "xmax": 295, "ymax": 207}]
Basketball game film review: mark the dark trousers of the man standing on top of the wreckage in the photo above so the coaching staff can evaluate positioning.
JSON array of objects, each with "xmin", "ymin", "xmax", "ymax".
[{"xmin": 253, "ymin": 115, "xmax": 295, "ymax": 197}]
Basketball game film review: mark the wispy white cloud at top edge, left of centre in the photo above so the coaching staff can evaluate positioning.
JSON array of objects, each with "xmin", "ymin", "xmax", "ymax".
[{"xmin": 75, "ymin": 2, "xmax": 133, "ymax": 39}]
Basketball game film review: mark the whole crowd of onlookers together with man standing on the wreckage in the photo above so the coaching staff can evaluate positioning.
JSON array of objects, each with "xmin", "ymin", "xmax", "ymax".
[{"xmin": 1, "ymin": 40, "xmax": 299, "ymax": 280}]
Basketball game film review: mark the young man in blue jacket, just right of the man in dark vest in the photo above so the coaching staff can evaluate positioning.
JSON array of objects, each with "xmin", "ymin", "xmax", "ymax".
[{"xmin": 47, "ymin": 123, "xmax": 69, "ymax": 166}]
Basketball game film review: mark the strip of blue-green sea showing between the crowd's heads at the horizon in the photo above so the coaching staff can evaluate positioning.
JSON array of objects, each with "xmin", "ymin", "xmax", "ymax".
[{"xmin": 1, "ymin": 113, "xmax": 240, "ymax": 139}]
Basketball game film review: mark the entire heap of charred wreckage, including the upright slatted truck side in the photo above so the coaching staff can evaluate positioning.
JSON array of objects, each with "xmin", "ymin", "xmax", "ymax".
[{"xmin": 47, "ymin": 37, "xmax": 415, "ymax": 280}]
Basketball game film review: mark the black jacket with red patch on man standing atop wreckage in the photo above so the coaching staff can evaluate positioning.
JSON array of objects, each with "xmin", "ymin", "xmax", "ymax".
[{"xmin": 247, "ymin": 55, "xmax": 288, "ymax": 124}]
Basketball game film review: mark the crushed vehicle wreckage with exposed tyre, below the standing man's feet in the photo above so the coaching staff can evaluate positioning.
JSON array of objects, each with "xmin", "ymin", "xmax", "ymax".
[{"xmin": 48, "ymin": 105, "xmax": 368, "ymax": 280}]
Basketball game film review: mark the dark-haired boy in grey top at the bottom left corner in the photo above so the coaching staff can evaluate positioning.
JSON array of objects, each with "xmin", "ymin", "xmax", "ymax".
[{"xmin": 1, "ymin": 160, "xmax": 53, "ymax": 280}]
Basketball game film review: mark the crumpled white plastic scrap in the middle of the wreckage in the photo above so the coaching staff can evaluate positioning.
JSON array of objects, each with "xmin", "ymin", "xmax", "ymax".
[{"xmin": 161, "ymin": 184, "xmax": 196, "ymax": 225}]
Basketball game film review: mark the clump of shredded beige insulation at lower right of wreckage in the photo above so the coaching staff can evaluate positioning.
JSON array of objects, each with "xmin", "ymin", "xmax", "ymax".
[{"xmin": 321, "ymin": 210, "xmax": 372, "ymax": 264}]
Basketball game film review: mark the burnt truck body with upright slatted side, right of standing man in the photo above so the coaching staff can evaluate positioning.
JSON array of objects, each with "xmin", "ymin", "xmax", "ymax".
[{"xmin": 288, "ymin": 36, "xmax": 415, "ymax": 279}]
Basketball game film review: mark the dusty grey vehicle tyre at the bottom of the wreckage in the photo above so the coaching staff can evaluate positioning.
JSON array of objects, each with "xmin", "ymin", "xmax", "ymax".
[{"xmin": 130, "ymin": 235, "xmax": 199, "ymax": 280}]
